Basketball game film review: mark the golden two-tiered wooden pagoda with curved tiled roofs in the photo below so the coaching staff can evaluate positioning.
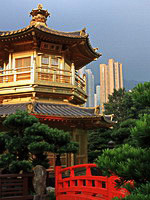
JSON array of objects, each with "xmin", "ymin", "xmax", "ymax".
[{"xmin": 0, "ymin": 4, "xmax": 113, "ymax": 165}]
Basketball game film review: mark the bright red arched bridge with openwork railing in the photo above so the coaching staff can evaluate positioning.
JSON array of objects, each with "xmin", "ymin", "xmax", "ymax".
[{"xmin": 55, "ymin": 164, "xmax": 129, "ymax": 200}]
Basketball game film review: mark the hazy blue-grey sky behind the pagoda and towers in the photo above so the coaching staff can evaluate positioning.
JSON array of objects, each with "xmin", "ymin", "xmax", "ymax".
[{"xmin": 0, "ymin": 0, "xmax": 150, "ymax": 81}]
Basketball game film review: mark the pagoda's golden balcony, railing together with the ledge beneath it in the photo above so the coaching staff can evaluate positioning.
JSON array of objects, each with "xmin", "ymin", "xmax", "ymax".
[{"xmin": 0, "ymin": 65, "xmax": 86, "ymax": 102}]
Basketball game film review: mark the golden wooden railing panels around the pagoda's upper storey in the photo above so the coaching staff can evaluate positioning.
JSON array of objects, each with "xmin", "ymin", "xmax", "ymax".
[{"xmin": 0, "ymin": 66, "xmax": 85, "ymax": 91}]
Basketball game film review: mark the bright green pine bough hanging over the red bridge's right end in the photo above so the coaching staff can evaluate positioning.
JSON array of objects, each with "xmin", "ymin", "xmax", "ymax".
[{"xmin": 96, "ymin": 144, "xmax": 150, "ymax": 184}]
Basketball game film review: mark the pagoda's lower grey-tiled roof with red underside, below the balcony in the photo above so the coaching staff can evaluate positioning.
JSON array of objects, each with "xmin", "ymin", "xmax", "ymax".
[{"xmin": 0, "ymin": 102, "xmax": 115, "ymax": 128}]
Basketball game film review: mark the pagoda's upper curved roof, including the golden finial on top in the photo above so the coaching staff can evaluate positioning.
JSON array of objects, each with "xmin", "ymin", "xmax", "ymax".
[{"xmin": 0, "ymin": 5, "xmax": 101, "ymax": 69}]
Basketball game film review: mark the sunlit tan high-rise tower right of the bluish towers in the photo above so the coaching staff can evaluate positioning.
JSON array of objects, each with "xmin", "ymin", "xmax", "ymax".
[{"xmin": 100, "ymin": 59, "xmax": 123, "ymax": 105}]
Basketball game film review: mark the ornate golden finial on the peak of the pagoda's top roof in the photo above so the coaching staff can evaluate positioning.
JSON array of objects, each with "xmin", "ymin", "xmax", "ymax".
[{"xmin": 30, "ymin": 4, "xmax": 50, "ymax": 26}]
